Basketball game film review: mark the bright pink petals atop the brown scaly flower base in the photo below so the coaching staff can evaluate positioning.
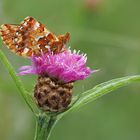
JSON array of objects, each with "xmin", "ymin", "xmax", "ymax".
[{"xmin": 19, "ymin": 50, "xmax": 94, "ymax": 83}]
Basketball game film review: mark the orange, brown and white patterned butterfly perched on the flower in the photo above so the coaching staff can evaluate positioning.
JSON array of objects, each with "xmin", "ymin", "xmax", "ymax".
[{"xmin": 0, "ymin": 17, "xmax": 70, "ymax": 57}]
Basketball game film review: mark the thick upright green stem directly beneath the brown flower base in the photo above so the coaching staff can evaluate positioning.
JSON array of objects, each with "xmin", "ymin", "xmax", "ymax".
[{"xmin": 34, "ymin": 115, "xmax": 56, "ymax": 140}]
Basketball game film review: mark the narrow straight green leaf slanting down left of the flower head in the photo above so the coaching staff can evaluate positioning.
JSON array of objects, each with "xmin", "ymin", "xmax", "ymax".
[{"xmin": 0, "ymin": 50, "xmax": 38, "ymax": 113}]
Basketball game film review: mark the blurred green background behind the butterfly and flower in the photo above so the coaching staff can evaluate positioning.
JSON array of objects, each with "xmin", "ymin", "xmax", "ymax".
[{"xmin": 0, "ymin": 0, "xmax": 140, "ymax": 140}]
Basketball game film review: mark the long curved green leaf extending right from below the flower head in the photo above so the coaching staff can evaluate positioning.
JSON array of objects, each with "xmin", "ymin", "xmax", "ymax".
[{"xmin": 59, "ymin": 75, "xmax": 140, "ymax": 119}]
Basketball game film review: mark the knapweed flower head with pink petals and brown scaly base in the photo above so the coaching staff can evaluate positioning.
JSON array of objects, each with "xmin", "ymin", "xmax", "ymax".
[{"xmin": 19, "ymin": 49, "xmax": 94, "ymax": 112}]
